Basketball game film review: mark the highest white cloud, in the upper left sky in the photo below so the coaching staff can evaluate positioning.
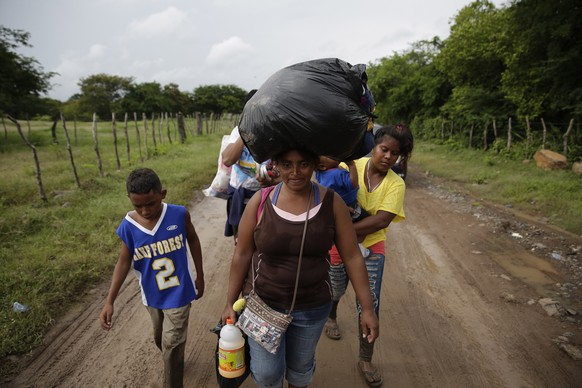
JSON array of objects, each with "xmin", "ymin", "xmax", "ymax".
[{"xmin": 128, "ymin": 6, "xmax": 187, "ymax": 39}]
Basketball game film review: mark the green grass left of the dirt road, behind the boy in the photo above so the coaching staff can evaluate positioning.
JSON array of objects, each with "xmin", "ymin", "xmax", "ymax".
[{"xmin": 0, "ymin": 122, "xmax": 232, "ymax": 377}]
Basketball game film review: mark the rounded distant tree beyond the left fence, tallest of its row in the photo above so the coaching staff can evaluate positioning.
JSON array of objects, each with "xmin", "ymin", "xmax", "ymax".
[{"xmin": 78, "ymin": 73, "xmax": 133, "ymax": 119}]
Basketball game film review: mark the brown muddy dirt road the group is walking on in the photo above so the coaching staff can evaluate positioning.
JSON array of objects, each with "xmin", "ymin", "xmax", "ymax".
[{"xmin": 4, "ymin": 168, "xmax": 582, "ymax": 388}]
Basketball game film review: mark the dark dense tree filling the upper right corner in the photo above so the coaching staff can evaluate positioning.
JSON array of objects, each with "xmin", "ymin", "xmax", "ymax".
[{"xmin": 502, "ymin": 0, "xmax": 582, "ymax": 121}]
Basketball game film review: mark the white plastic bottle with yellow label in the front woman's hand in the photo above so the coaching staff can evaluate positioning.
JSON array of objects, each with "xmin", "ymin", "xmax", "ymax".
[{"xmin": 218, "ymin": 318, "xmax": 246, "ymax": 379}]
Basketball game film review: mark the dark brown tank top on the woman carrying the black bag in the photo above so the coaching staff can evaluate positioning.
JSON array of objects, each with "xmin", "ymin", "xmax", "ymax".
[{"xmin": 243, "ymin": 186, "xmax": 335, "ymax": 310}]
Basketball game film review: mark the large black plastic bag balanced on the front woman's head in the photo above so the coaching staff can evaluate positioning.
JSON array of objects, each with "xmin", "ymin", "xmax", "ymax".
[{"xmin": 239, "ymin": 58, "xmax": 375, "ymax": 163}]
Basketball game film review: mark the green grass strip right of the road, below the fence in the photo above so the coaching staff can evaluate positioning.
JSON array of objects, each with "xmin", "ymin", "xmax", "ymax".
[{"xmin": 411, "ymin": 141, "xmax": 582, "ymax": 236}]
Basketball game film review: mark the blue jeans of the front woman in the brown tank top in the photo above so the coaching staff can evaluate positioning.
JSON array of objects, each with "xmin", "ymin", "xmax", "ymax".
[{"xmin": 248, "ymin": 303, "xmax": 331, "ymax": 387}]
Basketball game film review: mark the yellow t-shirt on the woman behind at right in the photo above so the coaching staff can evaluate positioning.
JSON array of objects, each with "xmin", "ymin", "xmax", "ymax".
[{"xmin": 354, "ymin": 158, "xmax": 406, "ymax": 247}]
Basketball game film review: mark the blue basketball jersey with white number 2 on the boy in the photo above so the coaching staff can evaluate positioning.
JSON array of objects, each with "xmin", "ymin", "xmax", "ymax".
[{"xmin": 117, "ymin": 203, "xmax": 196, "ymax": 309}]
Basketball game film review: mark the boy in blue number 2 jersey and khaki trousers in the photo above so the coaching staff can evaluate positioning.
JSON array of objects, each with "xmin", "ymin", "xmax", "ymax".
[{"xmin": 99, "ymin": 168, "xmax": 204, "ymax": 388}]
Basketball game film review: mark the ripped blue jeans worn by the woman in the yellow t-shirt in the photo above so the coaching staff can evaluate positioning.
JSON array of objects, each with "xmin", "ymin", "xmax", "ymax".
[{"xmin": 329, "ymin": 253, "xmax": 385, "ymax": 361}]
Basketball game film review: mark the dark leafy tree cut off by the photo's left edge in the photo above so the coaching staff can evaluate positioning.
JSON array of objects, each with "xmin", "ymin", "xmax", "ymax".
[{"xmin": 0, "ymin": 26, "xmax": 56, "ymax": 117}]
